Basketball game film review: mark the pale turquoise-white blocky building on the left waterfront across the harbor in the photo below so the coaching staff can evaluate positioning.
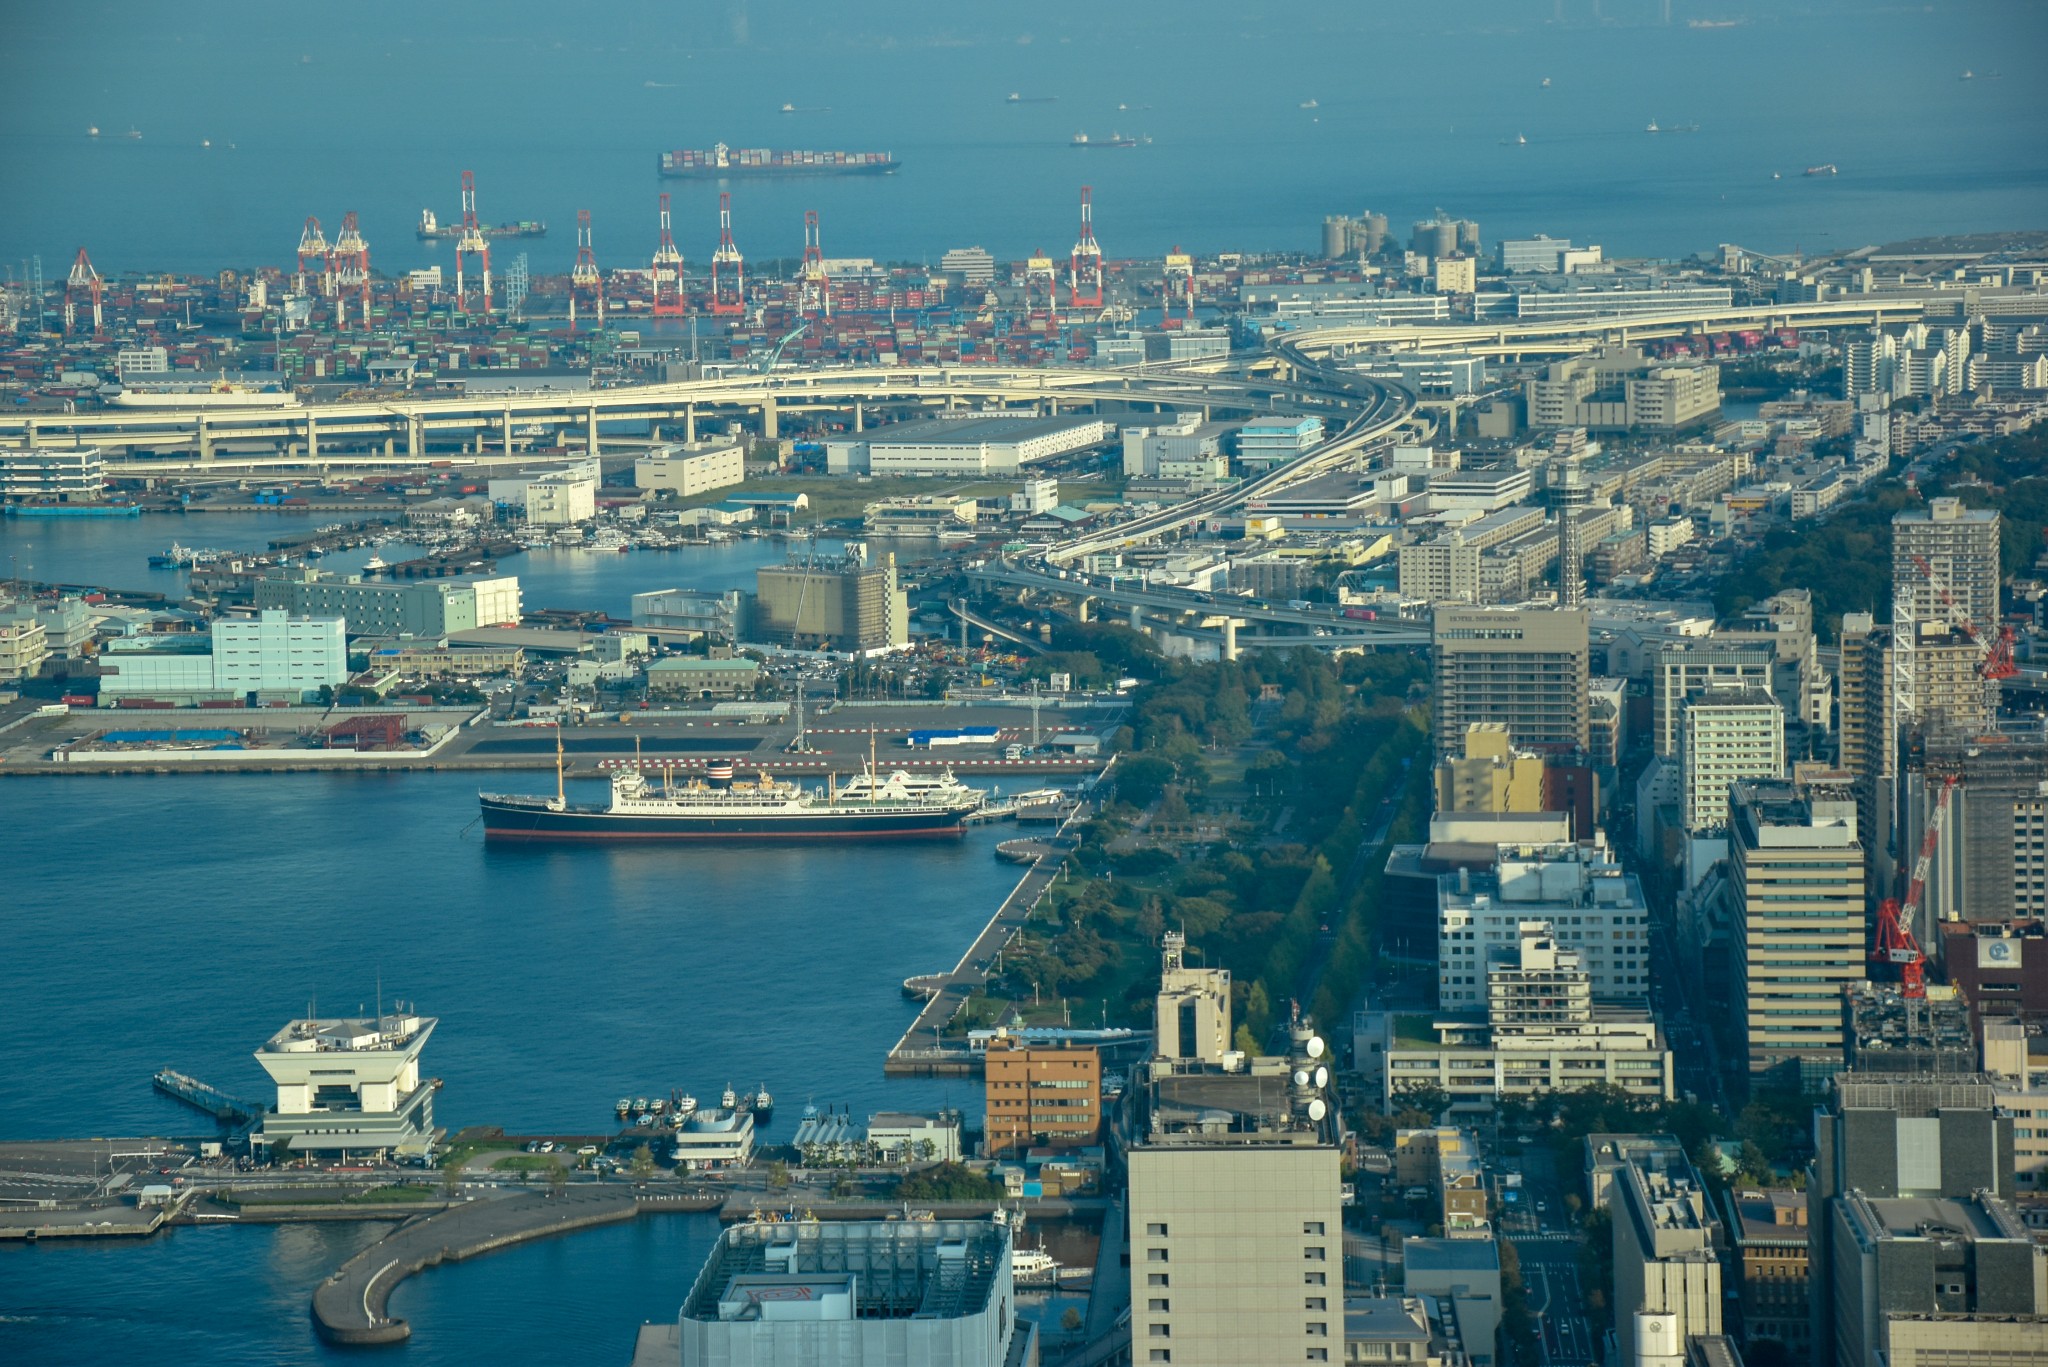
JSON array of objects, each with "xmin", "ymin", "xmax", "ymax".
[{"xmin": 100, "ymin": 609, "xmax": 348, "ymax": 705}]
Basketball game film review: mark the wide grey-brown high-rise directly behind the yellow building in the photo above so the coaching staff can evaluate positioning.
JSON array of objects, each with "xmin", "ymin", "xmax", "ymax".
[{"xmin": 1434, "ymin": 607, "xmax": 1591, "ymax": 754}]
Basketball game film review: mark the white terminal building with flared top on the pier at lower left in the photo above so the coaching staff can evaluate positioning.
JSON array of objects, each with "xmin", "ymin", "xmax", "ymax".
[{"xmin": 254, "ymin": 1010, "xmax": 438, "ymax": 1160}]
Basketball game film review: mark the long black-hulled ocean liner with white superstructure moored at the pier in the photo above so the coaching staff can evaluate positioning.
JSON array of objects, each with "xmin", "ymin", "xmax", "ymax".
[{"xmin": 479, "ymin": 760, "xmax": 987, "ymax": 840}]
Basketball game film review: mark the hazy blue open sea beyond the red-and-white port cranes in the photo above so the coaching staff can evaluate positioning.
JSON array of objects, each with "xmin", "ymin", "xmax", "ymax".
[{"xmin": 0, "ymin": 0, "xmax": 2048, "ymax": 279}]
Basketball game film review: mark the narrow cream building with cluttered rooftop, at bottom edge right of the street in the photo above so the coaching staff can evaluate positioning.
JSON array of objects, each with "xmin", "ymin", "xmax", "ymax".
[{"xmin": 1614, "ymin": 1154, "xmax": 1726, "ymax": 1363}]
